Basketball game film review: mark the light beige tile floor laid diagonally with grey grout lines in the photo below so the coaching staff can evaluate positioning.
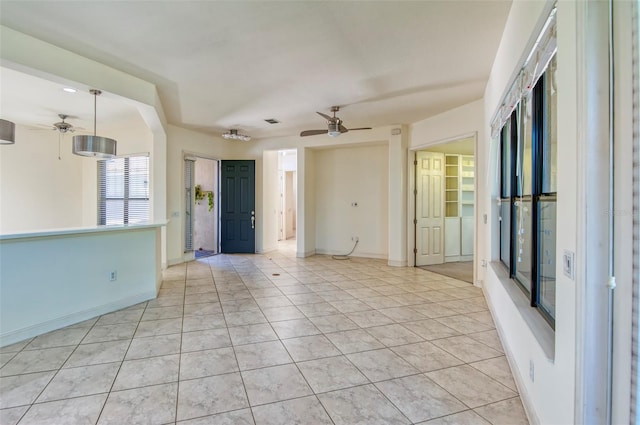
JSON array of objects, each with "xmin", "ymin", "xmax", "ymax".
[{"xmin": 0, "ymin": 250, "xmax": 527, "ymax": 425}]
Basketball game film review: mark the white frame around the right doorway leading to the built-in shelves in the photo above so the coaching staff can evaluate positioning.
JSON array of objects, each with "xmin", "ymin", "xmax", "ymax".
[{"xmin": 407, "ymin": 131, "xmax": 480, "ymax": 284}]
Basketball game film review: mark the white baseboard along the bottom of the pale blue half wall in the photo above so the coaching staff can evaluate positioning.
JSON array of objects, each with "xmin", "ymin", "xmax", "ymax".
[{"xmin": 0, "ymin": 291, "xmax": 157, "ymax": 347}]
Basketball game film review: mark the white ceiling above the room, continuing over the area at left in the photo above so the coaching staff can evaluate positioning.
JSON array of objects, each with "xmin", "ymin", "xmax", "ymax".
[{"xmin": 0, "ymin": 0, "xmax": 511, "ymax": 138}]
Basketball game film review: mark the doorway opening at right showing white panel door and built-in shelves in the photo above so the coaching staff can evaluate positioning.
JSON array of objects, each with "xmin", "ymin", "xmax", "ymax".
[{"xmin": 414, "ymin": 137, "xmax": 475, "ymax": 283}]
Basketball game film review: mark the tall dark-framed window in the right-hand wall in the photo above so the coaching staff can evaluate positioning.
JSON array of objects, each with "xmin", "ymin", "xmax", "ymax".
[{"xmin": 500, "ymin": 55, "xmax": 557, "ymax": 326}]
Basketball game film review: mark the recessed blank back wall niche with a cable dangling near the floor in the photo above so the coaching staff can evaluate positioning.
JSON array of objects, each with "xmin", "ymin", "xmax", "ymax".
[{"xmin": 314, "ymin": 145, "xmax": 389, "ymax": 259}]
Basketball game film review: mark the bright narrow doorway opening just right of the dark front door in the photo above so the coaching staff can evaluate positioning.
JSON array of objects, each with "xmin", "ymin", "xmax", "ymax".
[{"xmin": 278, "ymin": 149, "xmax": 298, "ymax": 250}]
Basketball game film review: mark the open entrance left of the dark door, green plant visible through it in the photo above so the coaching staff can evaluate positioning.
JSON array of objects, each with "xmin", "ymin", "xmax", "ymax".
[{"xmin": 185, "ymin": 156, "xmax": 220, "ymax": 258}]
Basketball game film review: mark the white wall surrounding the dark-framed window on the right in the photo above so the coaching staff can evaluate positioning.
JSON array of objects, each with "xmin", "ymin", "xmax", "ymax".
[{"xmin": 476, "ymin": 1, "xmax": 578, "ymax": 424}]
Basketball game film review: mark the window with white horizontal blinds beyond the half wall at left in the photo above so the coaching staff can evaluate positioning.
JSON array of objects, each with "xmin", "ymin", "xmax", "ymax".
[{"xmin": 98, "ymin": 156, "xmax": 149, "ymax": 225}]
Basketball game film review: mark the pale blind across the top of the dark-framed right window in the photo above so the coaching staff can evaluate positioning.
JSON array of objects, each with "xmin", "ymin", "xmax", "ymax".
[{"xmin": 491, "ymin": 7, "xmax": 558, "ymax": 138}]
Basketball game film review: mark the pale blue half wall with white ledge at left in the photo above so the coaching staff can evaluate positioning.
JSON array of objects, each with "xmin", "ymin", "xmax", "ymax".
[{"xmin": 0, "ymin": 227, "xmax": 161, "ymax": 346}]
